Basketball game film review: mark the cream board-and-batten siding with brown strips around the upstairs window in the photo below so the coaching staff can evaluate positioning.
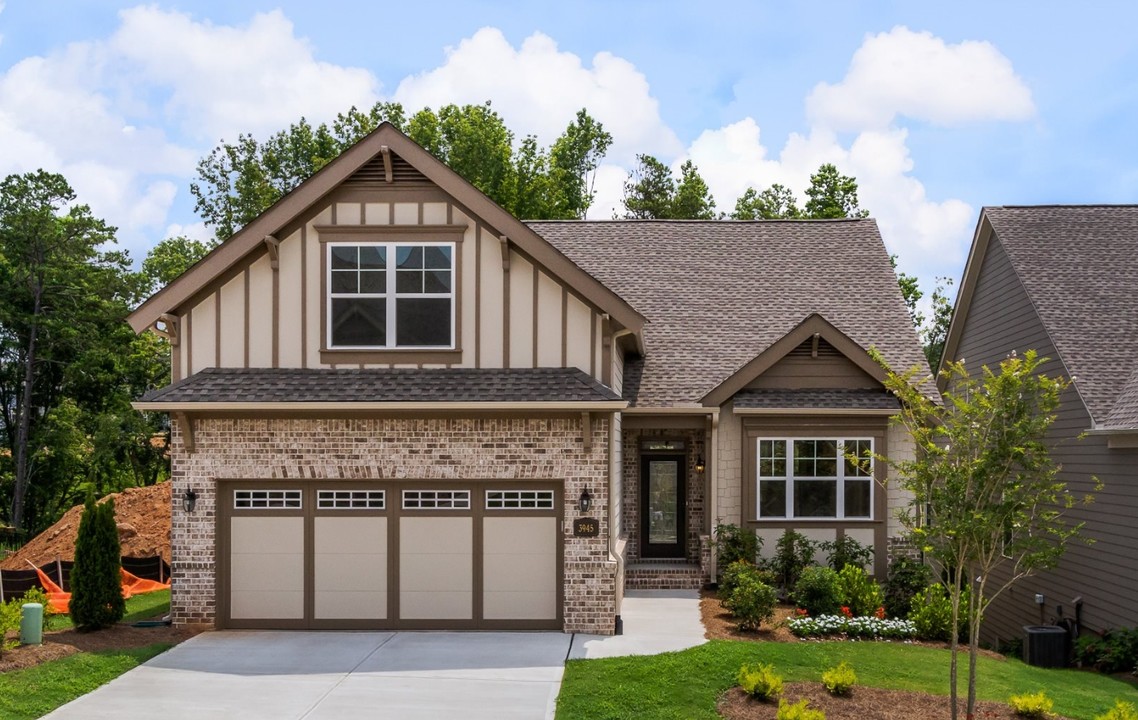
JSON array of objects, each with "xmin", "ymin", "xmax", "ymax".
[{"xmin": 174, "ymin": 195, "xmax": 611, "ymax": 381}]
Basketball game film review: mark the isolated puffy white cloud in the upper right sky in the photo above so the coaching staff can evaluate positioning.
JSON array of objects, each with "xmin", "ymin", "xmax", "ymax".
[{"xmin": 806, "ymin": 26, "xmax": 1036, "ymax": 131}]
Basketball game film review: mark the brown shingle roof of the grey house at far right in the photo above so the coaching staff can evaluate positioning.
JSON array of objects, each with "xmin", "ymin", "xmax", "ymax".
[{"xmin": 984, "ymin": 205, "xmax": 1138, "ymax": 428}]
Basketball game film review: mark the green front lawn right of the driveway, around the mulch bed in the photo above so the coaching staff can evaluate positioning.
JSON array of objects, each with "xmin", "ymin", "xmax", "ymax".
[{"xmin": 556, "ymin": 640, "xmax": 1138, "ymax": 720}]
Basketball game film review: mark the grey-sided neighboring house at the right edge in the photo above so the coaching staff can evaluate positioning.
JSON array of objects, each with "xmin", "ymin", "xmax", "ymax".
[{"xmin": 945, "ymin": 206, "xmax": 1138, "ymax": 639}]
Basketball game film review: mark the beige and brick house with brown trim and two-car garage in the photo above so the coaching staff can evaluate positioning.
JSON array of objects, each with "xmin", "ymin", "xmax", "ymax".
[{"xmin": 130, "ymin": 124, "xmax": 924, "ymax": 634}]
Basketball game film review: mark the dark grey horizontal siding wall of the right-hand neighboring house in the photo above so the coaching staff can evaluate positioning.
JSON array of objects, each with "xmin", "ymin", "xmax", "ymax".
[{"xmin": 954, "ymin": 235, "xmax": 1138, "ymax": 642}]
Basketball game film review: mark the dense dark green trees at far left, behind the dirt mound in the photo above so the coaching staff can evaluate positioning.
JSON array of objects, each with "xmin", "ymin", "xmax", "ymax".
[{"xmin": 0, "ymin": 171, "xmax": 168, "ymax": 530}]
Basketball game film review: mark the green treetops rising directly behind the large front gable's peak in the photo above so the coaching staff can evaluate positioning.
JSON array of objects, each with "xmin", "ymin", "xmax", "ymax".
[{"xmin": 190, "ymin": 102, "xmax": 612, "ymax": 240}]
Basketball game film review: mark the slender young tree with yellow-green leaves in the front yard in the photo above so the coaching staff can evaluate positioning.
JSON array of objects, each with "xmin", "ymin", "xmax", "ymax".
[{"xmin": 881, "ymin": 350, "xmax": 1090, "ymax": 720}]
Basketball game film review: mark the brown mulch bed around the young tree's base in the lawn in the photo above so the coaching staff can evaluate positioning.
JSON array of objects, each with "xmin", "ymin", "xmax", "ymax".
[{"xmin": 716, "ymin": 682, "xmax": 1064, "ymax": 720}]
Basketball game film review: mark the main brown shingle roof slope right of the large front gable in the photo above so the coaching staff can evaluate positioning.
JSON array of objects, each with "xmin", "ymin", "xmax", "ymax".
[{"xmin": 528, "ymin": 220, "xmax": 927, "ymax": 407}]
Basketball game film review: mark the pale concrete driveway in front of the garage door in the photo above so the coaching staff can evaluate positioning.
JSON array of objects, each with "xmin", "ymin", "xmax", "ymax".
[{"xmin": 47, "ymin": 631, "xmax": 572, "ymax": 720}]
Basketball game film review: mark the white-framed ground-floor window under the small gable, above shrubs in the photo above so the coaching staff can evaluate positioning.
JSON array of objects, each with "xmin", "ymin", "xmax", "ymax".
[{"xmin": 756, "ymin": 438, "xmax": 873, "ymax": 520}]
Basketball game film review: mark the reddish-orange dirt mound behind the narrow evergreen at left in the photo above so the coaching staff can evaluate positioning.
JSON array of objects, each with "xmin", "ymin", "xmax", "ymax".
[{"xmin": 0, "ymin": 481, "xmax": 171, "ymax": 570}]
